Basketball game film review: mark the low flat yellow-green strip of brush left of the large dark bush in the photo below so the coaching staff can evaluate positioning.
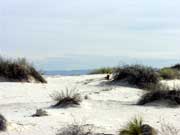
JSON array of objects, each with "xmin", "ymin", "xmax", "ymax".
[{"xmin": 89, "ymin": 67, "xmax": 116, "ymax": 74}]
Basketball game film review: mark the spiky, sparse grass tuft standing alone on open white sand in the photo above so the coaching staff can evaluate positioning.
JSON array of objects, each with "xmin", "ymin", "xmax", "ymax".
[{"xmin": 50, "ymin": 88, "xmax": 81, "ymax": 107}]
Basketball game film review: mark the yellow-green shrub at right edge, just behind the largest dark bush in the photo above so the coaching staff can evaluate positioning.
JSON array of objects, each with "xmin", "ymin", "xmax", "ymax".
[{"xmin": 159, "ymin": 68, "xmax": 180, "ymax": 79}]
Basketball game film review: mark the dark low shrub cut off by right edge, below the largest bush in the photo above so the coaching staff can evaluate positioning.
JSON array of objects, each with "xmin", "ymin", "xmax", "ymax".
[{"xmin": 137, "ymin": 85, "xmax": 180, "ymax": 105}]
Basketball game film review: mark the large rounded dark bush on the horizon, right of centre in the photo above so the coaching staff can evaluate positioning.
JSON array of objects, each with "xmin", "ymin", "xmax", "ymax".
[{"xmin": 113, "ymin": 65, "xmax": 160, "ymax": 89}]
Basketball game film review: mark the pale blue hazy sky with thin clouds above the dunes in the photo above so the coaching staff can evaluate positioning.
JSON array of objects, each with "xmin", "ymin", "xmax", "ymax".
[{"xmin": 0, "ymin": 0, "xmax": 180, "ymax": 70}]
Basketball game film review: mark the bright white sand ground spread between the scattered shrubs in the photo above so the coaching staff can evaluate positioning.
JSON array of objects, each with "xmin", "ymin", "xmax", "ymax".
[{"xmin": 0, "ymin": 75, "xmax": 180, "ymax": 135}]
